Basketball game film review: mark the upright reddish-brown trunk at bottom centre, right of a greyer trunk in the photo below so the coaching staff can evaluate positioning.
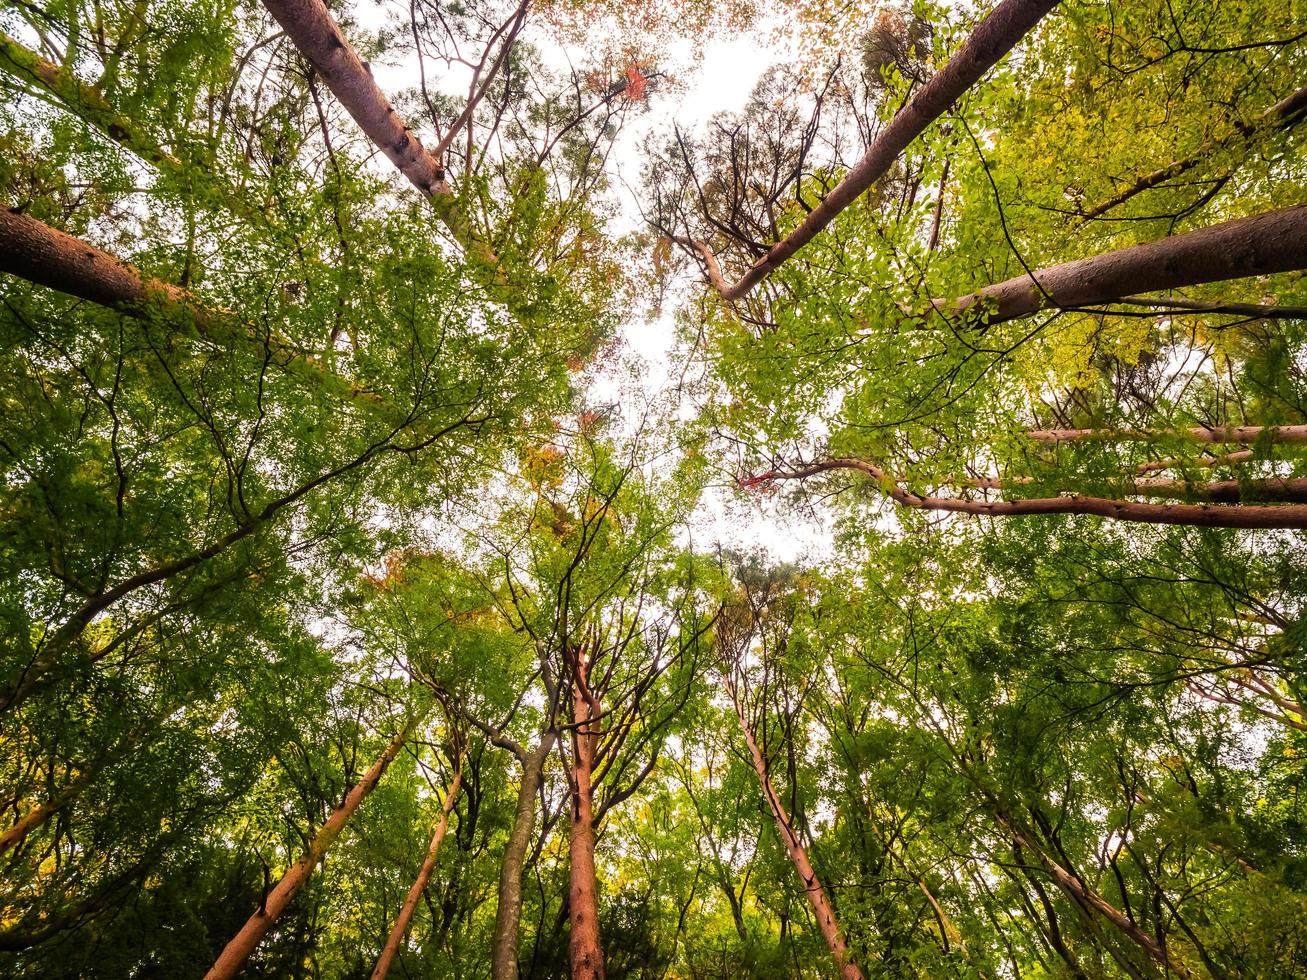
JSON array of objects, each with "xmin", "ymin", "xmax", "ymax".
[{"xmin": 567, "ymin": 652, "xmax": 604, "ymax": 980}]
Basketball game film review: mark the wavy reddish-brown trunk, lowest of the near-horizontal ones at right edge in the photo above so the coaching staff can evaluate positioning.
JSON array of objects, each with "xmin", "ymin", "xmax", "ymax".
[{"xmin": 742, "ymin": 459, "xmax": 1307, "ymax": 528}]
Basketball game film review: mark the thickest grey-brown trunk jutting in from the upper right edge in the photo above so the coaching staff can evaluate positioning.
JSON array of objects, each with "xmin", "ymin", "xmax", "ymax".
[{"xmin": 951, "ymin": 204, "xmax": 1307, "ymax": 324}]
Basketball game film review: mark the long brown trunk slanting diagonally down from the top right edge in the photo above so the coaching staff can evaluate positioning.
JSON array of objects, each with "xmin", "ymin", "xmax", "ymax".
[{"xmin": 721, "ymin": 0, "xmax": 1057, "ymax": 301}]
